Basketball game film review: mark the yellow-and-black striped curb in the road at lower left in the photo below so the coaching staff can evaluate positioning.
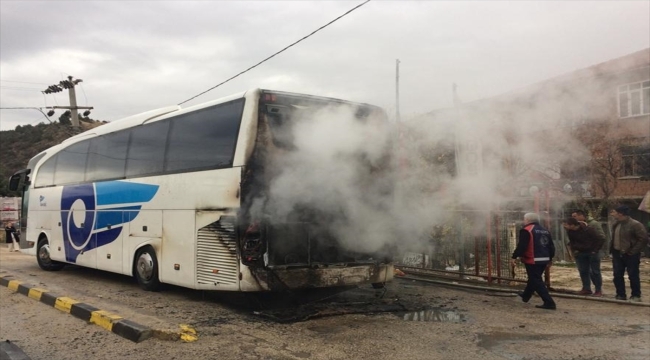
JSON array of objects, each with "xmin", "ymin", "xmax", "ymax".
[{"xmin": 0, "ymin": 275, "xmax": 154, "ymax": 343}]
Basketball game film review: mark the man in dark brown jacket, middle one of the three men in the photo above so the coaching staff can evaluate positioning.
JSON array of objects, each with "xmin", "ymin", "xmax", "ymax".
[{"xmin": 563, "ymin": 217, "xmax": 605, "ymax": 297}]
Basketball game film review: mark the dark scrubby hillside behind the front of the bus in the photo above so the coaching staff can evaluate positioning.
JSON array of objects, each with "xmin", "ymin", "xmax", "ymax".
[{"xmin": 0, "ymin": 119, "xmax": 104, "ymax": 196}]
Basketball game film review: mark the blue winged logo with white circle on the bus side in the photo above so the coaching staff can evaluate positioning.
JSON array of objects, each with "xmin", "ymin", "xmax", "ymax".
[{"xmin": 61, "ymin": 181, "xmax": 158, "ymax": 262}]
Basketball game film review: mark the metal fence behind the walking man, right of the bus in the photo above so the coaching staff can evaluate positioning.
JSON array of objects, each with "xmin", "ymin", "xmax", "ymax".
[{"xmin": 397, "ymin": 209, "xmax": 571, "ymax": 284}]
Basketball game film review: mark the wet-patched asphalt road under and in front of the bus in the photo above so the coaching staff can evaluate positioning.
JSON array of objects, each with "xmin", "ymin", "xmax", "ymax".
[{"xmin": 0, "ymin": 247, "xmax": 650, "ymax": 360}]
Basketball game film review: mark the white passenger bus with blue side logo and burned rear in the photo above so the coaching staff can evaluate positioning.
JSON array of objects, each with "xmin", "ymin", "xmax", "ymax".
[{"xmin": 10, "ymin": 89, "xmax": 393, "ymax": 291}]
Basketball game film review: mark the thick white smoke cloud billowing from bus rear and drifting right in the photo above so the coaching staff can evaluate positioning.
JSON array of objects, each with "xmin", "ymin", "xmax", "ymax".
[{"xmin": 258, "ymin": 67, "xmax": 628, "ymax": 251}]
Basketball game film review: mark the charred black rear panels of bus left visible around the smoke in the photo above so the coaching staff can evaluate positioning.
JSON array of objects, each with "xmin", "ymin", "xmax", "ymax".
[{"xmin": 239, "ymin": 90, "xmax": 393, "ymax": 290}]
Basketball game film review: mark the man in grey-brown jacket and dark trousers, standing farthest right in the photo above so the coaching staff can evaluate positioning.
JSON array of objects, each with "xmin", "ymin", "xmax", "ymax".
[{"xmin": 609, "ymin": 205, "xmax": 648, "ymax": 302}]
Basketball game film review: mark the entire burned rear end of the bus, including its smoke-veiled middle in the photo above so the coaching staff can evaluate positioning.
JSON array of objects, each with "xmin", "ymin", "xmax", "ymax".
[{"xmin": 237, "ymin": 90, "xmax": 394, "ymax": 291}]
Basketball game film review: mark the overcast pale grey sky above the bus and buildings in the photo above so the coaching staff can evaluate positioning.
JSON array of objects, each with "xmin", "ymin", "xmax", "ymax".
[{"xmin": 0, "ymin": 0, "xmax": 650, "ymax": 130}]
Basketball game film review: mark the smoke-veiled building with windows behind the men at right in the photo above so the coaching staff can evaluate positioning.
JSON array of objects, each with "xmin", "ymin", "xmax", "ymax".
[{"xmin": 411, "ymin": 48, "xmax": 650, "ymax": 221}]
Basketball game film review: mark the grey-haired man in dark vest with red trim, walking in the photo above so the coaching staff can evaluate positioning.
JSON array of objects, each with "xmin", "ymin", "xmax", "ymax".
[{"xmin": 510, "ymin": 213, "xmax": 556, "ymax": 310}]
